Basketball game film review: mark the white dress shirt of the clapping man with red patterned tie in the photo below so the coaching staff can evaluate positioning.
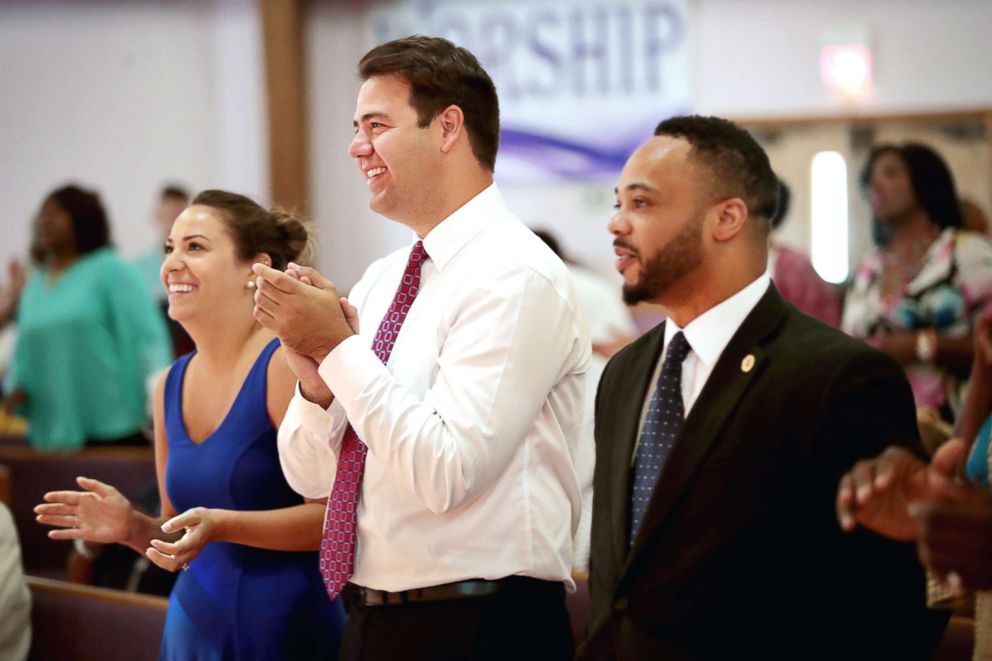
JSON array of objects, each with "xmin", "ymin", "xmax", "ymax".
[{"xmin": 279, "ymin": 185, "xmax": 591, "ymax": 591}]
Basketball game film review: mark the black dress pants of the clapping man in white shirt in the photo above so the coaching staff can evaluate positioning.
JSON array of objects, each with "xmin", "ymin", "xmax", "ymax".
[{"xmin": 339, "ymin": 576, "xmax": 573, "ymax": 661}]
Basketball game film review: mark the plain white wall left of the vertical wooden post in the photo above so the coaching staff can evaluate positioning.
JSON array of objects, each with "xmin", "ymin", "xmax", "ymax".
[{"xmin": 0, "ymin": 0, "xmax": 268, "ymax": 277}]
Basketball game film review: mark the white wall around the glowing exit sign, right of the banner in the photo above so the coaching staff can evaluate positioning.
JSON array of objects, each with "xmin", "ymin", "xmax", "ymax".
[{"xmin": 693, "ymin": 0, "xmax": 992, "ymax": 117}]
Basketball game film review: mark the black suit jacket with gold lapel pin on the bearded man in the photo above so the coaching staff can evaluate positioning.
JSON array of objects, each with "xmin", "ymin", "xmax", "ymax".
[{"xmin": 579, "ymin": 285, "xmax": 946, "ymax": 659}]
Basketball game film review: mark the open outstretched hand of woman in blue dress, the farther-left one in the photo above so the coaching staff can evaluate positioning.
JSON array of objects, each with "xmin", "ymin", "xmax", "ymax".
[{"xmin": 34, "ymin": 477, "xmax": 131, "ymax": 544}]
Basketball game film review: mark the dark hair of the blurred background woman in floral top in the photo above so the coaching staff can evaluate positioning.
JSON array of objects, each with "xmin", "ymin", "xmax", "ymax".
[{"xmin": 861, "ymin": 142, "xmax": 964, "ymax": 240}]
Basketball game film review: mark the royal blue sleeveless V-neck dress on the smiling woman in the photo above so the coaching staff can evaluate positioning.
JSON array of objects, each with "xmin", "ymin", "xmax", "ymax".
[{"xmin": 160, "ymin": 340, "xmax": 344, "ymax": 661}]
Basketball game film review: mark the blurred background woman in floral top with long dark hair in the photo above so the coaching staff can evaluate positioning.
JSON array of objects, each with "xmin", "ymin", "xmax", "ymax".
[{"xmin": 842, "ymin": 143, "xmax": 992, "ymax": 440}]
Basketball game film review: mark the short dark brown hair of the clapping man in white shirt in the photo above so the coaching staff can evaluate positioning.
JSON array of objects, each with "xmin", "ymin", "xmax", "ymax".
[{"xmin": 358, "ymin": 35, "xmax": 499, "ymax": 172}]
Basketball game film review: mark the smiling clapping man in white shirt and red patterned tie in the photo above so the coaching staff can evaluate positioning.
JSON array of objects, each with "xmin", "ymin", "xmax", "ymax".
[{"xmin": 256, "ymin": 37, "xmax": 590, "ymax": 659}]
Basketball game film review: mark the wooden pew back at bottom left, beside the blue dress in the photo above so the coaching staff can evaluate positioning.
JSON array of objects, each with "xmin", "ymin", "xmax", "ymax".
[{"xmin": 27, "ymin": 576, "xmax": 169, "ymax": 661}]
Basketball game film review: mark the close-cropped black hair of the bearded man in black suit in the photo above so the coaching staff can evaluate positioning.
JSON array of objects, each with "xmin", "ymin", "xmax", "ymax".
[{"xmin": 654, "ymin": 115, "xmax": 778, "ymax": 231}]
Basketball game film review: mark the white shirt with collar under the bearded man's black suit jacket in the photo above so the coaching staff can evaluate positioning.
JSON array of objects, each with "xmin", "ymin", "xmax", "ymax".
[{"xmin": 635, "ymin": 273, "xmax": 771, "ymax": 438}]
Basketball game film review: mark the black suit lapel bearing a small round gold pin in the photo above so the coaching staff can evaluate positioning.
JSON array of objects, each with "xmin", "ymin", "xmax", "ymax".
[{"xmin": 625, "ymin": 285, "xmax": 787, "ymax": 569}]
